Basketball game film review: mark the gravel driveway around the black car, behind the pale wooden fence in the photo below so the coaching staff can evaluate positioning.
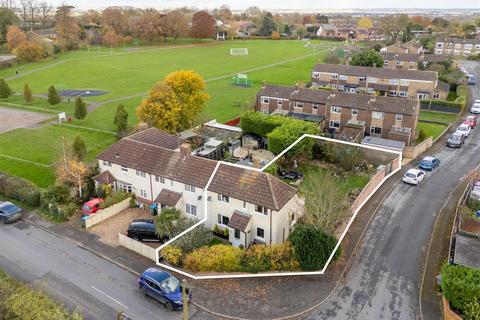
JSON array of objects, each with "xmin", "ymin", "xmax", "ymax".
[{"xmin": 88, "ymin": 208, "xmax": 152, "ymax": 247}]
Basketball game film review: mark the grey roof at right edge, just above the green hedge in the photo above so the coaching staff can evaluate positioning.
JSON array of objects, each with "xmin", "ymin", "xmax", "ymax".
[{"xmin": 453, "ymin": 234, "xmax": 480, "ymax": 269}]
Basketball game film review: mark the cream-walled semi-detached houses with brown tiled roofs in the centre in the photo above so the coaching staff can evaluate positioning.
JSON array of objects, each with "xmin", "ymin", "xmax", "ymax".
[{"xmin": 94, "ymin": 128, "xmax": 303, "ymax": 247}]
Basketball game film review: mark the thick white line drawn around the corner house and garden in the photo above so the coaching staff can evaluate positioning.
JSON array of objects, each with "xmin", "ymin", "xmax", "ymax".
[{"xmin": 155, "ymin": 134, "xmax": 402, "ymax": 280}]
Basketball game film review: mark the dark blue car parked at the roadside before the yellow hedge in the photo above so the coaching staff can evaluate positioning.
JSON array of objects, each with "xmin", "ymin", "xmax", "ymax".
[{"xmin": 138, "ymin": 268, "xmax": 192, "ymax": 311}]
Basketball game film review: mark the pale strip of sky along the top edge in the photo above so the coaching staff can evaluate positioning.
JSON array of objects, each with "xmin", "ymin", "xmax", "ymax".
[{"xmin": 53, "ymin": 0, "xmax": 480, "ymax": 11}]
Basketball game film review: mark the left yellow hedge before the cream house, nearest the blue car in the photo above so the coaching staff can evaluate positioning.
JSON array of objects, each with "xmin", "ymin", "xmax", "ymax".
[{"xmin": 183, "ymin": 244, "xmax": 242, "ymax": 272}]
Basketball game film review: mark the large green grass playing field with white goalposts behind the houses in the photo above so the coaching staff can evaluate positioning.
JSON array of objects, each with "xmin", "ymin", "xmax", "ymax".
[{"xmin": 0, "ymin": 40, "xmax": 338, "ymax": 186}]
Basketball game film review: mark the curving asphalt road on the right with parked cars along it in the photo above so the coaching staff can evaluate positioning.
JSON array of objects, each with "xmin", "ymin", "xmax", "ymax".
[{"xmin": 308, "ymin": 62, "xmax": 480, "ymax": 320}]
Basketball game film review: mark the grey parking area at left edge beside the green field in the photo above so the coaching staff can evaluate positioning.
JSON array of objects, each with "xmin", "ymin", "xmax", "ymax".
[{"xmin": 0, "ymin": 107, "xmax": 52, "ymax": 133}]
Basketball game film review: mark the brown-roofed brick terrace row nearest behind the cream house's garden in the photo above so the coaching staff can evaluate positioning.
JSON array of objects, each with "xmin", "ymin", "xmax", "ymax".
[{"xmin": 256, "ymin": 85, "xmax": 420, "ymax": 145}]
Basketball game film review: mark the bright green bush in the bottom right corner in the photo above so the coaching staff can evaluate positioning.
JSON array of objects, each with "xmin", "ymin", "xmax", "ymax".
[{"xmin": 441, "ymin": 264, "xmax": 480, "ymax": 313}]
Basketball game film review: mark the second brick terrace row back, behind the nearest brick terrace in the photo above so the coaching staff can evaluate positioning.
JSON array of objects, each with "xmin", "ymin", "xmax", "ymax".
[{"xmin": 312, "ymin": 64, "xmax": 448, "ymax": 99}]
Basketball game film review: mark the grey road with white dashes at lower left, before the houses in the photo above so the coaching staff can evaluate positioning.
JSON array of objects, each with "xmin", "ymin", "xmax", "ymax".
[{"xmin": 0, "ymin": 221, "xmax": 188, "ymax": 320}]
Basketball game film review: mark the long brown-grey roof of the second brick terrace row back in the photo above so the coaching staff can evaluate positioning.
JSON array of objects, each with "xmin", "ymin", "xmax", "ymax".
[{"xmin": 313, "ymin": 64, "xmax": 438, "ymax": 81}]
